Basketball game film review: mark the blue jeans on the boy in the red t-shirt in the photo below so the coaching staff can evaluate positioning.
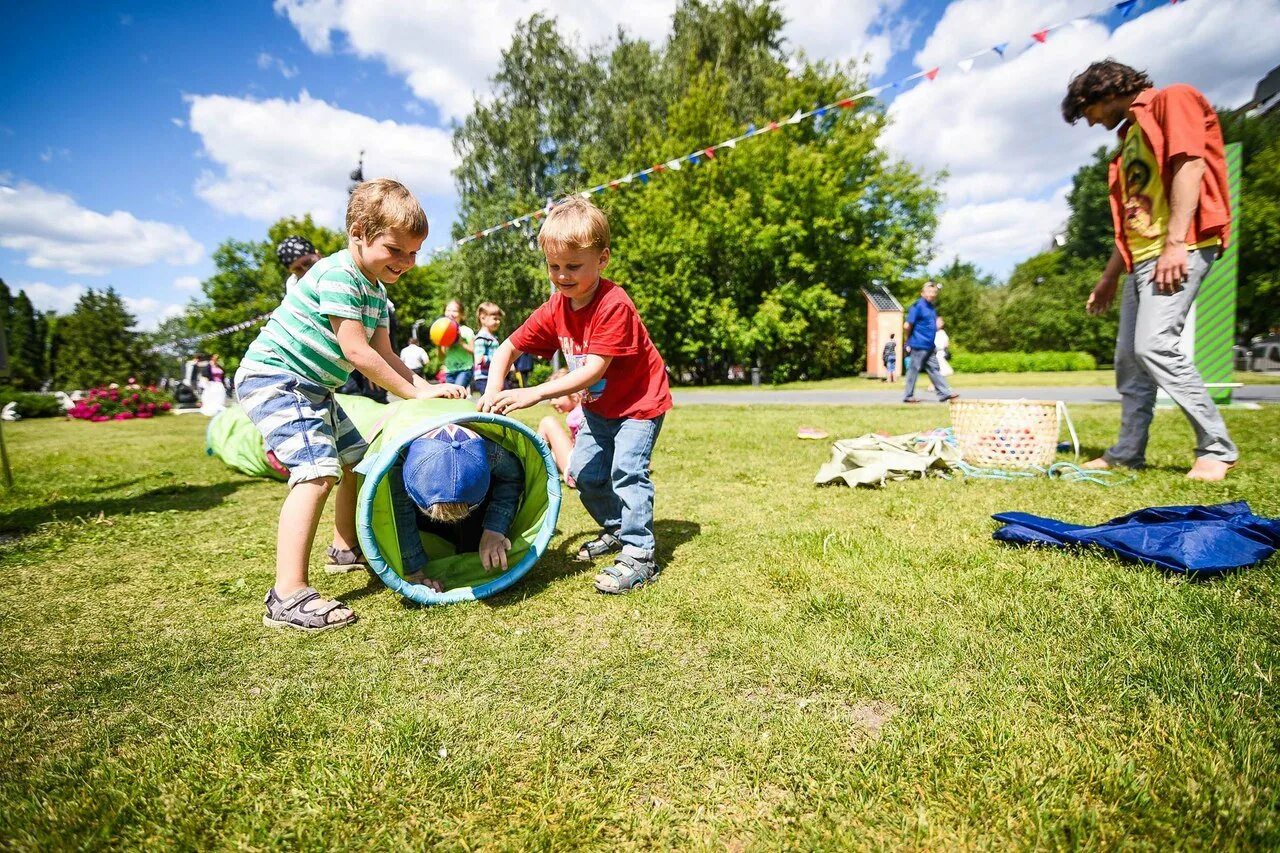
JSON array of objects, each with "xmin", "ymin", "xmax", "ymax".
[{"xmin": 568, "ymin": 409, "xmax": 663, "ymax": 560}]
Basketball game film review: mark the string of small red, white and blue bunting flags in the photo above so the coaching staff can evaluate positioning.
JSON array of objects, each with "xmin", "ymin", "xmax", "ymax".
[{"xmin": 180, "ymin": 0, "xmax": 1179, "ymax": 348}]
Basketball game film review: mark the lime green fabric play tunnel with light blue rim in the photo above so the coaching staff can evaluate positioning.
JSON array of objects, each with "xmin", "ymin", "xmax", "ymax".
[{"xmin": 206, "ymin": 396, "xmax": 561, "ymax": 605}]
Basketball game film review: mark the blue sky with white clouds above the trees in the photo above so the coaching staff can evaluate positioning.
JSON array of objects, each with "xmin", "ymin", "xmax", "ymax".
[{"xmin": 0, "ymin": 0, "xmax": 1280, "ymax": 324}]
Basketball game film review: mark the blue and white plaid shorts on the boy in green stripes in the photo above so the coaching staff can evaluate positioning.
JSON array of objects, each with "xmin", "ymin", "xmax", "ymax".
[{"xmin": 236, "ymin": 368, "xmax": 369, "ymax": 487}]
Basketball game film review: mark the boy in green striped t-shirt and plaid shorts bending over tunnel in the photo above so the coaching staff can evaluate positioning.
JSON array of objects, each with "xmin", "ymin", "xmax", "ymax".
[{"xmin": 236, "ymin": 178, "xmax": 466, "ymax": 631}]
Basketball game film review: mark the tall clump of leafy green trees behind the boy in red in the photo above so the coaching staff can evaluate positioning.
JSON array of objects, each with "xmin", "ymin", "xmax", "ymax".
[{"xmin": 447, "ymin": 0, "xmax": 937, "ymax": 379}]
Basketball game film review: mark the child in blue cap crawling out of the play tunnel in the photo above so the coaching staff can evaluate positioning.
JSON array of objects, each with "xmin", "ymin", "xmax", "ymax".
[{"xmin": 387, "ymin": 424, "xmax": 525, "ymax": 592}]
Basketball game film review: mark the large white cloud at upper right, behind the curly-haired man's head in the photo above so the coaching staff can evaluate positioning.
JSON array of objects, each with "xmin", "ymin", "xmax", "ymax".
[{"xmin": 883, "ymin": 0, "xmax": 1280, "ymax": 273}]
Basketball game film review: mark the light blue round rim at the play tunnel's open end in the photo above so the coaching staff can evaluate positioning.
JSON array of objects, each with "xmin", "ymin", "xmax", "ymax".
[{"xmin": 356, "ymin": 412, "xmax": 562, "ymax": 605}]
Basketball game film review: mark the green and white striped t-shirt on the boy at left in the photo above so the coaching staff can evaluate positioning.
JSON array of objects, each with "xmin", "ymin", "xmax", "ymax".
[{"xmin": 241, "ymin": 248, "xmax": 389, "ymax": 388}]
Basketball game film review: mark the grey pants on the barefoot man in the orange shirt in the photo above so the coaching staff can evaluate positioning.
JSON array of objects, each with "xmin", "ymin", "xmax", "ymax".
[{"xmin": 1103, "ymin": 246, "xmax": 1239, "ymax": 467}]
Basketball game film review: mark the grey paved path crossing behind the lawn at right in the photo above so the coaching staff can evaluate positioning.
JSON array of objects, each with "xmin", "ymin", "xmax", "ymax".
[{"xmin": 672, "ymin": 383, "xmax": 1280, "ymax": 406}]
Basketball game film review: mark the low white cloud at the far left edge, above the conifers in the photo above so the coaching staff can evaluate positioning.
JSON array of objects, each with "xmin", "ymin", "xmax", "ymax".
[{"xmin": 0, "ymin": 183, "xmax": 205, "ymax": 275}]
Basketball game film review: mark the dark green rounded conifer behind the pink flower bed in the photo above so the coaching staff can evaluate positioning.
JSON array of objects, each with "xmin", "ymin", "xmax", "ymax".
[{"xmin": 56, "ymin": 287, "xmax": 148, "ymax": 388}]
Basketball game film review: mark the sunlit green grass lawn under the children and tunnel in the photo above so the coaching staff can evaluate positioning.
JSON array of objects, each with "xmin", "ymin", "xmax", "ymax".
[{"xmin": 0, "ymin": 406, "xmax": 1280, "ymax": 849}]
